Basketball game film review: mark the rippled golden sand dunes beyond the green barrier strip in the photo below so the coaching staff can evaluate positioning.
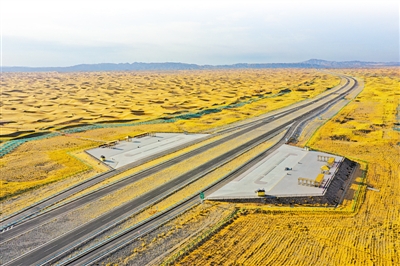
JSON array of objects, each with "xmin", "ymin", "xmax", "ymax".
[{"xmin": 0, "ymin": 69, "xmax": 335, "ymax": 139}]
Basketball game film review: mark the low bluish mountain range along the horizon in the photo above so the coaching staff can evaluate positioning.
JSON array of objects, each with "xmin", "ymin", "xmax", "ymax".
[{"xmin": 2, "ymin": 59, "xmax": 400, "ymax": 72}]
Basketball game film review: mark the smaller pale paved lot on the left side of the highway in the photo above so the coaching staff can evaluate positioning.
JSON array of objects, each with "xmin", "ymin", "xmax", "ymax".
[{"xmin": 87, "ymin": 133, "xmax": 208, "ymax": 169}]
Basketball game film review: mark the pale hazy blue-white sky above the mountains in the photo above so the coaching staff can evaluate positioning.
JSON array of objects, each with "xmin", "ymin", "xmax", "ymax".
[{"xmin": 0, "ymin": 0, "xmax": 400, "ymax": 66}]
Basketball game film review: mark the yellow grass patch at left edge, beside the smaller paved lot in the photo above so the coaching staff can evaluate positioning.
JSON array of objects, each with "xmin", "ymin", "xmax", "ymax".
[{"xmin": 0, "ymin": 137, "xmax": 97, "ymax": 201}]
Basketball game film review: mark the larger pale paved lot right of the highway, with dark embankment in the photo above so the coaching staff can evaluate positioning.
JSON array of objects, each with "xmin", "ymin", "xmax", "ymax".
[{"xmin": 207, "ymin": 145, "xmax": 343, "ymax": 199}]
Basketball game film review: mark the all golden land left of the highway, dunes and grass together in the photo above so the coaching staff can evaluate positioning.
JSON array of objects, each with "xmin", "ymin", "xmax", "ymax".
[{"xmin": 0, "ymin": 70, "xmax": 339, "ymax": 209}]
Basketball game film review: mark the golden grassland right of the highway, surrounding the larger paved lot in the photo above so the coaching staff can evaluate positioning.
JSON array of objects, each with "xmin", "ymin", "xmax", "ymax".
[{"xmin": 174, "ymin": 68, "xmax": 400, "ymax": 265}]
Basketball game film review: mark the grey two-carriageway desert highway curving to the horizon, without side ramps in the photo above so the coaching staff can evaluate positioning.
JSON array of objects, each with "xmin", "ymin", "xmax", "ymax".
[{"xmin": 2, "ymin": 77, "xmax": 357, "ymax": 265}]
